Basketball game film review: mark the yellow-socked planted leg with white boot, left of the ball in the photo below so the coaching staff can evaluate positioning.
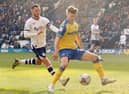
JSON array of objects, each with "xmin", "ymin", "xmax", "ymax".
[{"xmin": 48, "ymin": 57, "xmax": 69, "ymax": 92}]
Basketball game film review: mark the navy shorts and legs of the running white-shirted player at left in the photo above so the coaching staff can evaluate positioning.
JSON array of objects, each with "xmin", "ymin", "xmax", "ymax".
[{"xmin": 12, "ymin": 47, "xmax": 55, "ymax": 75}]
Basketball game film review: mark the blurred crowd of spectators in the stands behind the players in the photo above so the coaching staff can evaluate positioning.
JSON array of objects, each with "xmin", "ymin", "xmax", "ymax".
[{"xmin": 0, "ymin": 0, "xmax": 129, "ymax": 48}]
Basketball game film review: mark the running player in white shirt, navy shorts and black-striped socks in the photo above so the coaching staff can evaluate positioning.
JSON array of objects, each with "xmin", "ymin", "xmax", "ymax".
[{"xmin": 12, "ymin": 4, "xmax": 69, "ymax": 86}]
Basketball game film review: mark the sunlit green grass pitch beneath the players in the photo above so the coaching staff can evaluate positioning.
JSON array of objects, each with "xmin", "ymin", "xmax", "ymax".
[{"xmin": 0, "ymin": 53, "xmax": 129, "ymax": 94}]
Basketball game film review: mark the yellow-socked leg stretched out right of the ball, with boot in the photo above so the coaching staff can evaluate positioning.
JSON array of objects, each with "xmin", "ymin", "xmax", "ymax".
[{"xmin": 81, "ymin": 52, "xmax": 116, "ymax": 85}]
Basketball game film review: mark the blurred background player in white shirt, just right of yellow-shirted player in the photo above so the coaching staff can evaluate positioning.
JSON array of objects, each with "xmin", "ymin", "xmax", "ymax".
[{"xmin": 89, "ymin": 18, "xmax": 101, "ymax": 52}]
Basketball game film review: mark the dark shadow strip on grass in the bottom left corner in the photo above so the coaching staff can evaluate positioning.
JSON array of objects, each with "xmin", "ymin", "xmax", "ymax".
[{"xmin": 0, "ymin": 88, "xmax": 29, "ymax": 94}]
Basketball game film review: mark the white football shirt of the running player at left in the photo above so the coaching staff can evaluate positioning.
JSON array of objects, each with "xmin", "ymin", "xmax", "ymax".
[{"xmin": 24, "ymin": 16, "xmax": 50, "ymax": 48}]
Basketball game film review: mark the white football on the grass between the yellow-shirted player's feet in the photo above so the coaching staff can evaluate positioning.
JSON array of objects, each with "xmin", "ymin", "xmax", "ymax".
[{"xmin": 80, "ymin": 73, "xmax": 91, "ymax": 85}]
